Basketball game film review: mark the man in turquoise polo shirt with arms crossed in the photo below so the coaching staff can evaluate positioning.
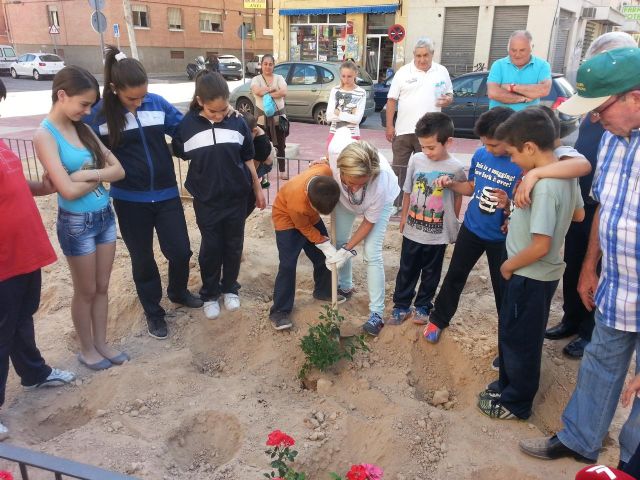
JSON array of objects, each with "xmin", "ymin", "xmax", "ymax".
[{"xmin": 487, "ymin": 30, "xmax": 551, "ymax": 111}]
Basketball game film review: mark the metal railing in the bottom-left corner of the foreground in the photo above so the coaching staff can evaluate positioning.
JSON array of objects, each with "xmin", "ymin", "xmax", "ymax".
[{"xmin": 0, "ymin": 443, "xmax": 136, "ymax": 480}]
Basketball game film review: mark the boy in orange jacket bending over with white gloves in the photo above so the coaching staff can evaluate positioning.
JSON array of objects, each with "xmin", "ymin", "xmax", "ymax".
[{"xmin": 269, "ymin": 165, "xmax": 340, "ymax": 330}]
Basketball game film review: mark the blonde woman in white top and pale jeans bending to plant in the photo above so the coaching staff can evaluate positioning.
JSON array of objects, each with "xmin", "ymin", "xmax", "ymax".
[{"xmin": 327, "ymin": 128, "xmax": 400, "ymax": 335}]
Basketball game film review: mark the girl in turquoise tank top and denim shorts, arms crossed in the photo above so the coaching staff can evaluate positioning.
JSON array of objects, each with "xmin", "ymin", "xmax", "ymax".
[{"xmin": 33, "ymin": 66, "xmax": 129, "ymax": 370}]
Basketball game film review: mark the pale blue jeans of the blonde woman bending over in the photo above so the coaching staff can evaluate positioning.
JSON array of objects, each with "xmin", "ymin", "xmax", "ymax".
[{"xmin": 335, "ymin": 202, "xmax": 393, "ymax": 317}]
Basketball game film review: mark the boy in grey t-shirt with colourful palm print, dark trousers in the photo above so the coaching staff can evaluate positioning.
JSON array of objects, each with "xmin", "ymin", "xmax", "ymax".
[{"xmin": 391, "ymin": 112, "xmax": 467, "ymax": 324}]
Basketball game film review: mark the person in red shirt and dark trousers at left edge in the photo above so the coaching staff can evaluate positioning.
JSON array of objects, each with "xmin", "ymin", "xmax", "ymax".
[{"xmin": 0, "ymin": 80, "xmax": 75, "ymax": 441}]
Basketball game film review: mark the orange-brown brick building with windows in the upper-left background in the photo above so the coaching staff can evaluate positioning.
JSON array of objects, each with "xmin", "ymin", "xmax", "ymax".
[{"xmin": 0, "ymin": 0, "xmax": 273, "ymax": 73}]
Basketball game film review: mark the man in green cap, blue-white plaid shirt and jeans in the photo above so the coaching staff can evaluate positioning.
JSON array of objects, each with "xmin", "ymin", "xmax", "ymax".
[{"xmin": 520, "ymin": 47, "xmax": 640, "ymax": 467}]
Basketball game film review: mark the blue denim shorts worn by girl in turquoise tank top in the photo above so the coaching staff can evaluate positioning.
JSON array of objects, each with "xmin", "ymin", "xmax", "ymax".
[{"xmin": 57, "ymin": 205, "xmax": 116, "ymax": 257}]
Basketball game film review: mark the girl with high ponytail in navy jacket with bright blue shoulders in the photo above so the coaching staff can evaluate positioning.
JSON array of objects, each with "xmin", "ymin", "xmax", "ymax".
[{"xmin": 85, "ymin": 46, "xmax": 202, "ymax": 338}]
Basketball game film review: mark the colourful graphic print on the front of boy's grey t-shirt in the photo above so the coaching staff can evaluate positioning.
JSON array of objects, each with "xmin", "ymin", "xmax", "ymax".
[{"xmin": 407, "ymin": 171, "xmax": 454, "ymax": 234}]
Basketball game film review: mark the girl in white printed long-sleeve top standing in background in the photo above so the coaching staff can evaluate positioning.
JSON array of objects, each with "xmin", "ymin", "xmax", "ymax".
[{"xmin": 327, "ymin": 60, "xmax": 367, "ymax": 145}]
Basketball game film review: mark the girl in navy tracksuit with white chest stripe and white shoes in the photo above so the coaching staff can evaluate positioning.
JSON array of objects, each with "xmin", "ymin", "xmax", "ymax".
[{"xmin": 173, "ymin": 71, "xmax": 266, "ymax": 319}]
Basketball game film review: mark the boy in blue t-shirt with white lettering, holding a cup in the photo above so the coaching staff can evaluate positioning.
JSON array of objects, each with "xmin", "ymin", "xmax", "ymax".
[{"xmin": 423, "ymin": 107, "xmax": 522, "ymax": 343}]
